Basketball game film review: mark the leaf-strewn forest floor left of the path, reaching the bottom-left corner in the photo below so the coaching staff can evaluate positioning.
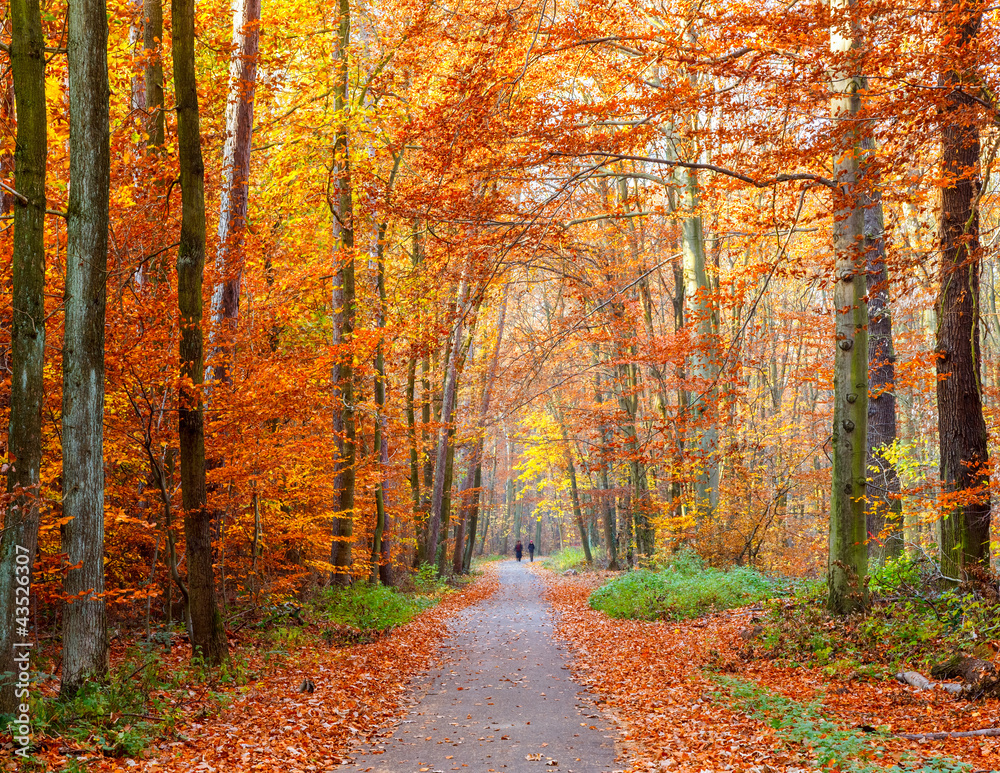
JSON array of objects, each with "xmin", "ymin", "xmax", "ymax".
[{"xmin": 11, "ymin": 565, "xmax": 497, "ymax": 773}]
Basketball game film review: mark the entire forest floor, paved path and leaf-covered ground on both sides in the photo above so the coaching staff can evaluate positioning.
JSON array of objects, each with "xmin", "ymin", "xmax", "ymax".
[{"xmin": 9, "ymin": 563, "xmax": 1000, "ymax": 773}]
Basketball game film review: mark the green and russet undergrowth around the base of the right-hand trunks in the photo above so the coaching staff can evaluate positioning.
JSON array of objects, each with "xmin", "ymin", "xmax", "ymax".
[{"xmin": 751, "ymin": 557, "xmax": 1000, "ymax": 679}]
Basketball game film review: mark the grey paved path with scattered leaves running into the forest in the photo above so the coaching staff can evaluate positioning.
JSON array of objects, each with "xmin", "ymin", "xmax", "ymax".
[{"xmin": 337, "ymin": 561, "xmax": 615, "ymax": 773}]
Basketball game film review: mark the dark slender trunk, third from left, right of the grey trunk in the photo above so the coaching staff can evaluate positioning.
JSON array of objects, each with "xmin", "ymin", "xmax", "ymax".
[{"xmin": 171, "ymin": 0, "xmax": 229, "ymax": 666}]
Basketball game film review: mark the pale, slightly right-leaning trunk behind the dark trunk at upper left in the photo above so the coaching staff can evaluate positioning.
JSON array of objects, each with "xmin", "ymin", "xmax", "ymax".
[{"xmin": 211, "ymin": 0, "xmax": 260, "ymax": 383}]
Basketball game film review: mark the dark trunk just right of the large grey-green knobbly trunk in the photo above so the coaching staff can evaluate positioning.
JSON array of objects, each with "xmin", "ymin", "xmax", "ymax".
[{"xmin": 862, "ymin": 137, "xmax": 903, "ymax": 559}]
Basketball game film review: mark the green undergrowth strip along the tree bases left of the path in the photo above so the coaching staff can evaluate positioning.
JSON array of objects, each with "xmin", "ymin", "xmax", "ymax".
[{"xmin": 0, "ymin": 567, "xmax": 450, "ymax": 770}]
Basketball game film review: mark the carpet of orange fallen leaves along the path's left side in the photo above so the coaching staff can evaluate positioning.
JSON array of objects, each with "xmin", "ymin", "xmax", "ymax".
[{"xmin": 25, "ymin": 565, "xmax": 497, "ymax": 773}]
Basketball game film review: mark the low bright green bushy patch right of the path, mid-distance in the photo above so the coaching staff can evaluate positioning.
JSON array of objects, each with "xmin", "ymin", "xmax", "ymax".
[{"xmin": 590, "ymin": 551, "xmax": 778, "ymax": 620}]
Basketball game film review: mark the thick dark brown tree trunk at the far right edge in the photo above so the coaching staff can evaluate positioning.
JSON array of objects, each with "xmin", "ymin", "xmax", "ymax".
[{"xmin": 937, "ymin": 0, "xmax": 990, "ymax": 578}]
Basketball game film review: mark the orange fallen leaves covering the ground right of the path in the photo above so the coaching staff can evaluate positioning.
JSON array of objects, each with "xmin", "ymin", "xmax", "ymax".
[{"xmin": 541, "ymin": 572, "xmax": 1000, "ymax": 773}]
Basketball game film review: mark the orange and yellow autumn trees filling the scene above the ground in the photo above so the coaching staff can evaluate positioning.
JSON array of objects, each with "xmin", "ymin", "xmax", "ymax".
[{"xmin": 0, "ymin": 0, "xmax": 1000, "ymax": 770}]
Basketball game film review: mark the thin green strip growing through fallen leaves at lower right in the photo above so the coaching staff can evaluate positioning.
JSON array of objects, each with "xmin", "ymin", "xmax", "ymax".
[{"xmin": 708, "ymin": 674, "xmax": 972, "ymax": 773}]
